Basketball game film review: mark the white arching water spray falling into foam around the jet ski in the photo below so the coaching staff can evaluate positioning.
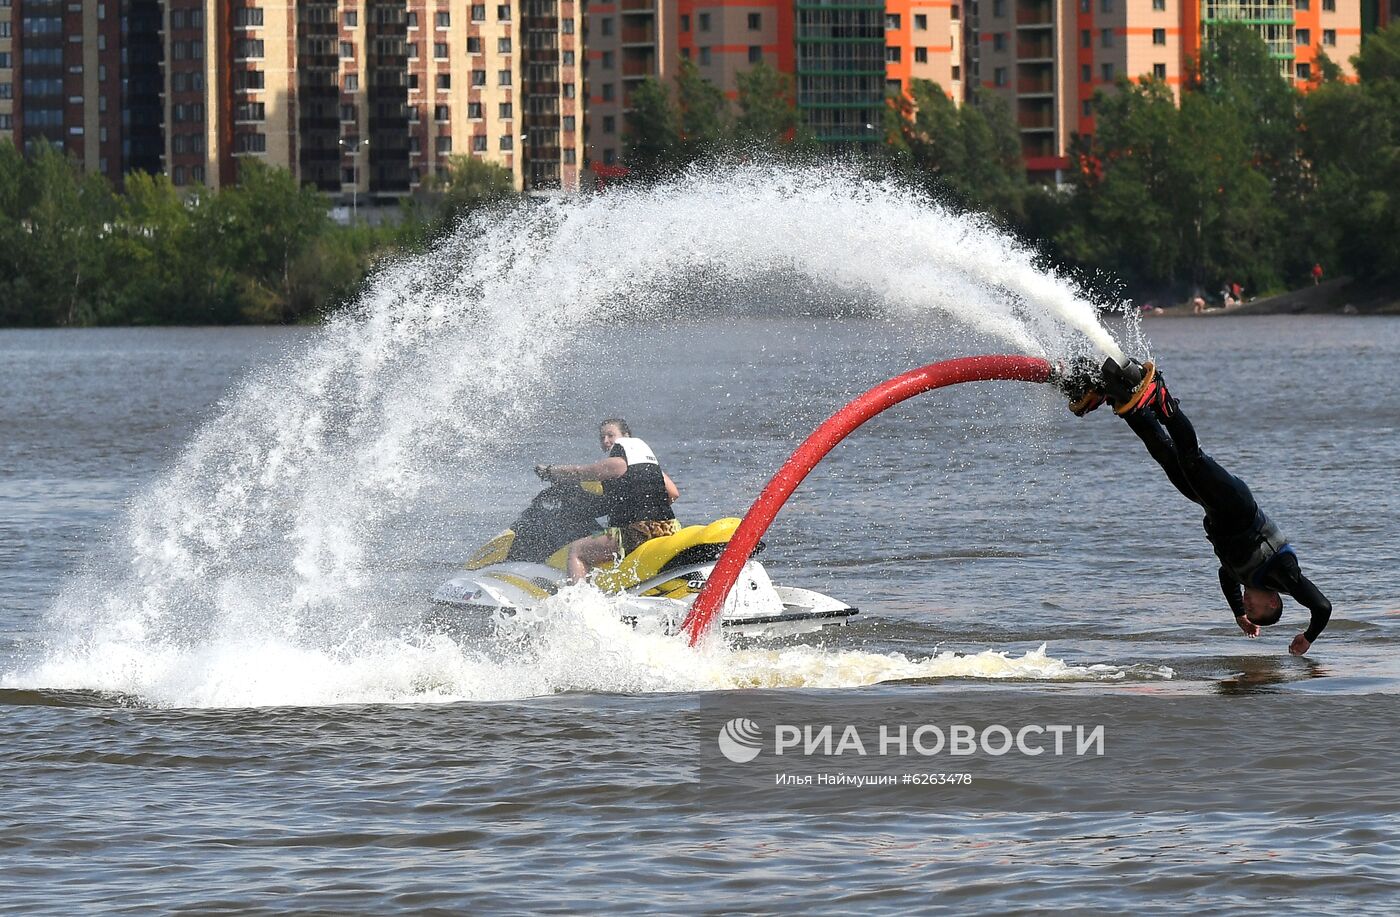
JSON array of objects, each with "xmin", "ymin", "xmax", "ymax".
[{"xmin": 6, "ymin": 165, "xmax": 1148, "ymax": 706}]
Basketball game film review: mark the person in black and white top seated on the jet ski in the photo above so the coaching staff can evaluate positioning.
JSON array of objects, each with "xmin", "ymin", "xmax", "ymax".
[{"xmin": 535, "ymin": 417, "xmax": 680, "ymax": 582}]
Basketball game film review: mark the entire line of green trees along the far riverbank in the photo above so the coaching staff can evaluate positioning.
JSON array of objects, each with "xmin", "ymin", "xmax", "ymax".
[{"xmin": 0, "ymin": 25, "xmax": 1400, "ymax": 326}]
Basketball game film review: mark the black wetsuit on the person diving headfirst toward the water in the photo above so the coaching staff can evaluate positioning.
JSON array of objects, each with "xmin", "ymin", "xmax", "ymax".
[{"xmin": 1124, "ymin": 396, "xmax": 1331, "ymax": 643}]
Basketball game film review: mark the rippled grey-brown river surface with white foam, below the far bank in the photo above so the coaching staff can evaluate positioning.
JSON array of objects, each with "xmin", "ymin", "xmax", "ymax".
[{"xmin": 0, "ymin": 315, "xmax": 1400, "ymax": 914}]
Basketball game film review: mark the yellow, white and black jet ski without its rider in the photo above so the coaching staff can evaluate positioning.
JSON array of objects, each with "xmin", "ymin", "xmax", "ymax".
[{"xmin": 433, "ymin": 482, "xmax": 857, "ymax": 637}]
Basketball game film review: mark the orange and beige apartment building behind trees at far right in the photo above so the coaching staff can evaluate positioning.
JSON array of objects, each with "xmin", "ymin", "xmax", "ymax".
[{"xmin": 967, "ymin": 0, "xmax": 1361, "ymax": 178}]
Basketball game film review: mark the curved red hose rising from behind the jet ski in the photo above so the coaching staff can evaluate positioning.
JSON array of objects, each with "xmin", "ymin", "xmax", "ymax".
[{"xmin": 682, "ymin": 356, "xmax": 1050, "ymax": 647}]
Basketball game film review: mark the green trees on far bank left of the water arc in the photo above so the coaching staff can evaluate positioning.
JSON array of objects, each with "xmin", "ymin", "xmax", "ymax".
[{"xmin": 0, "ymin": 141, "xmax": 514, "ymax": 326}]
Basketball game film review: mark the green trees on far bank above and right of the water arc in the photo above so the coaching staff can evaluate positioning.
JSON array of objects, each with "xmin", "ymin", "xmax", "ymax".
[{"xmin": 626, "ymin": 25, "xmax": 1400, "ymax": 300}]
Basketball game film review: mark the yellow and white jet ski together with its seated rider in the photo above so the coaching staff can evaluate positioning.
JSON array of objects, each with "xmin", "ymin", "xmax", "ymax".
[{"xmin": 434, "ymin": 421, "xmax": 855, "ymax": 636}]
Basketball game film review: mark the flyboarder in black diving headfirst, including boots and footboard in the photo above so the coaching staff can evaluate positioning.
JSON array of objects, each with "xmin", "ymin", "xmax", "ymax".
[{"xmin": 1051, "ymin": 358, "xmax": 1331, "ymax": 655}]
